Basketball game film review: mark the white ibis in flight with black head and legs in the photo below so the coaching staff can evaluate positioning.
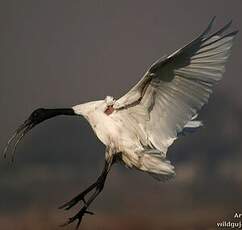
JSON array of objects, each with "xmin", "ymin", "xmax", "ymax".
[{"xmin": 3, "ymin": 17, "xmax": 238, "ymax": 229}]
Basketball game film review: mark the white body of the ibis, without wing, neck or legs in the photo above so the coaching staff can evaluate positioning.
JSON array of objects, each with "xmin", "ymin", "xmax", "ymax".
[{"xmin": 73, "ymin": 97, "xmax": 174, "ymax": 178}]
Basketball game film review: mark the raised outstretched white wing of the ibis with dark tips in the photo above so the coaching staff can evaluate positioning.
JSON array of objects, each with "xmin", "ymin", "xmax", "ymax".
[{"xmin": 114, "ymin": 18, "xmax": 237, "ymax": 154}]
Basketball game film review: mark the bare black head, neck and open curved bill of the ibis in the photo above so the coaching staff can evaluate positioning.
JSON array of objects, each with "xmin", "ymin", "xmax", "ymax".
[{"xmin": 4, "ymin": 108, "xmax": 76, "ymax": 160}]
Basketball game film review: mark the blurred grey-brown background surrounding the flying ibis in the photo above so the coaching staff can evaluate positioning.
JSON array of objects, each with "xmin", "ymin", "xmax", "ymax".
[{"xmin": 0, "ymin": 0, "xmax": 242, "ymax": 230}]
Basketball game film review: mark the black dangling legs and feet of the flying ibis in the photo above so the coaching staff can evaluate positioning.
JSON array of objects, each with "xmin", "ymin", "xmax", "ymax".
[{"xmin": 60, "ymin": 157, "xmax": 113, "ymax": 229}]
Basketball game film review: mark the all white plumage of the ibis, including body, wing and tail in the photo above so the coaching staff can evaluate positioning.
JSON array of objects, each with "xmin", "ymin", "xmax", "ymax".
[{"xmin": 74, "ymin": 17, "xmax": 236, "ymax": 179}]
